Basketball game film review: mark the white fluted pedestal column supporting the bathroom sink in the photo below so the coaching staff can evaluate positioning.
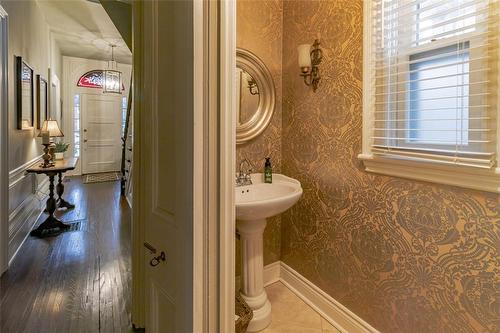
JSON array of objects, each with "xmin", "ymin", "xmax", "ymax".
[{"xmin": 236, "ymin": 219, "xmax": 271, "ymax": 332}]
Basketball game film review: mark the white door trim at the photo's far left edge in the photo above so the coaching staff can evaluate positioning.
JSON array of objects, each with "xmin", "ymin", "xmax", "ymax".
[{"xmin": 0, "ymin": 6, "xmax": 9, "ymax": 275}]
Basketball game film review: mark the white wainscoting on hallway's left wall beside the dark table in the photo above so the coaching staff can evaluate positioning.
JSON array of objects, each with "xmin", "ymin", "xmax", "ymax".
[{"xmin": 8, "ymin": 156, "xmax": 49, "ymax": 263}]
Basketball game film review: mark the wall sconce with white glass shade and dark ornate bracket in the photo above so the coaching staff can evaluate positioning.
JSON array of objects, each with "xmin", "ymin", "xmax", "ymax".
[{"xmin": 297, "ymin": 39, "xmax": 323, "ymax": 92}]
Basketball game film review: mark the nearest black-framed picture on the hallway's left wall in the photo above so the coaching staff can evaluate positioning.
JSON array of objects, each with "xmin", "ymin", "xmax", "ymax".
[{"xmin": 16, "ymin": 57, "xmax": 35, "ymax": 129}]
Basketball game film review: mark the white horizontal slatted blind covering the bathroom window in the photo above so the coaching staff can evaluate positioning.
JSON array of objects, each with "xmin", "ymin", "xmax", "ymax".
[{"xmin": 371, "ymin": 0, "xmax": 498, "ymax": 169}]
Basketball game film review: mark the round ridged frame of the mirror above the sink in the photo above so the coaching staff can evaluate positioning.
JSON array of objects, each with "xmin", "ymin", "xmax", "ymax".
[{"xmin": 236, "ymin": 48, "xmax": 276, "ymax": 145}]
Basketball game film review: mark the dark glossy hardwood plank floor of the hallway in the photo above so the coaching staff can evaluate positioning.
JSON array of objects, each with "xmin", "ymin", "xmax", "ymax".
[{"xmin": 0, "ymin": 177, "xmax": 132, "ymax": 333}]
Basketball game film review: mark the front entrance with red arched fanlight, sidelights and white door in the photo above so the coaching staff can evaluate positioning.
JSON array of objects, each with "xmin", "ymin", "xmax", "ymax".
[{"xmin": 66, "ymin": 56, "xmax": 133, "ymax": 178}]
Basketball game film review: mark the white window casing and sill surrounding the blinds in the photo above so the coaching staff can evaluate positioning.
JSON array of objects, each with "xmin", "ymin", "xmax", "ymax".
[{"xmin": 358, "ymin": 0, "xmax": 500, "ymax": 193}]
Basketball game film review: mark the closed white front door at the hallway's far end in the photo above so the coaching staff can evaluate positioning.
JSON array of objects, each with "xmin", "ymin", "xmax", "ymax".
[{"xmin": 81, "ymin": 94, "xmax": 122, "ymax": 174}]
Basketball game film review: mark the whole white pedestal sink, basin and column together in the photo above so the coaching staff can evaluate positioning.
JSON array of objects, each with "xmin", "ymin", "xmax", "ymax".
[{"xmin": 235, "ymin": 173, "xmax": 302, "ymax": 332}]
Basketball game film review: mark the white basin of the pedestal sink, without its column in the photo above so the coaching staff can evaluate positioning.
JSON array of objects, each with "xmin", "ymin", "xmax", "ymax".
[{"xmin": 235, "ymin": 173, "xmax": 302, "ymax": 221}]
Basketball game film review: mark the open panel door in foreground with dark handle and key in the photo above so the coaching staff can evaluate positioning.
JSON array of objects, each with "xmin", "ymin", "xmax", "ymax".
[{"xmin": 138, "ymin": 0, "xmax": 203, "ymax": 333}]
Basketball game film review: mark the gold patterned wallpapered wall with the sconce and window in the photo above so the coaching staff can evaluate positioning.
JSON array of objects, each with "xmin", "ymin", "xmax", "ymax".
[{"xmin": 282, "ymin": 0, "xmax": 500, "ymax": 333}]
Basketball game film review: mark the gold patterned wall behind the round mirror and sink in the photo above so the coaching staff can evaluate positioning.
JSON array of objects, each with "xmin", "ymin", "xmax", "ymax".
[{"xmin": 236, "ymin": 0, "xmax": 283, "ymax": 264}]
